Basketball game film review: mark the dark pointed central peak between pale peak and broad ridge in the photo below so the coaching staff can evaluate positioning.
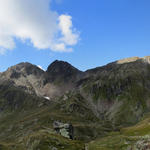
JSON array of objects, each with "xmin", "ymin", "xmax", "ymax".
[{"xmin": 44, "ymin": 60, "xmax": 84, "ymax": 97}]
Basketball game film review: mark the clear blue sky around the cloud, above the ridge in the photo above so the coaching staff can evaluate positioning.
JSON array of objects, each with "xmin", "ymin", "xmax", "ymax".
[{"xmin": 0, "ymin": 0, "xmax": 150, "ymax": 71}]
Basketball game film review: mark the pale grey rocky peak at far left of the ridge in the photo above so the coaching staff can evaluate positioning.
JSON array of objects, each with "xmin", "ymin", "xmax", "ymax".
[{"xmin": 0, "ymin": 63, "xmax": 44, "ymax": 95}]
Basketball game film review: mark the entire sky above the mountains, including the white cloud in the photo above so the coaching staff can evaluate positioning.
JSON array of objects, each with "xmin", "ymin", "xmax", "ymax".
[{"xmin": 0, "ymin": 0, "xmax": 150, "ymax": 72}]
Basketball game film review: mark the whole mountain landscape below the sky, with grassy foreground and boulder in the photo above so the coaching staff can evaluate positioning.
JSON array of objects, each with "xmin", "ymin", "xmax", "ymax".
[{"xmin": 0, "ymin": 56, "xmax": 150, "ymax": 150}]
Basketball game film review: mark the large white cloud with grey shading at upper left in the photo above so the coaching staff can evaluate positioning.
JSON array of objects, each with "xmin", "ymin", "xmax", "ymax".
[{"xmin": 0, "ymin": 0, "xmax": 79, "ymax": 53}]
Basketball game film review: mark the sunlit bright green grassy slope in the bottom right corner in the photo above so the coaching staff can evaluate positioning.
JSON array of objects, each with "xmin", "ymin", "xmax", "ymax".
[{"xmin": 87, "ymin": 114, "xmax": 150, "ymax": 150}]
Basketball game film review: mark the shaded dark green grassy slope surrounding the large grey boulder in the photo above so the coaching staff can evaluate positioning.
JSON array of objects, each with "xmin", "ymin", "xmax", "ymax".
[{"xmin": 0, "ymin": 82, "xmax": 108, "ymax": 150}]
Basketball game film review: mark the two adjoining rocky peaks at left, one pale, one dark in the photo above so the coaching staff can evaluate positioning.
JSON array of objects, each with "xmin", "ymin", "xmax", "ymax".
[{"xmin": 0, "ymin": 60, "xmax": 83, "ymax": 98}]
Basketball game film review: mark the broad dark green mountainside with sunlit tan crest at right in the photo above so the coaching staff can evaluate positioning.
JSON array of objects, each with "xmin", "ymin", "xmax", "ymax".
[{"xmin": 79, "ymin": 57, "xmax": 150, "ymax": 125}]
